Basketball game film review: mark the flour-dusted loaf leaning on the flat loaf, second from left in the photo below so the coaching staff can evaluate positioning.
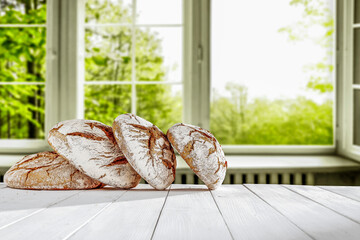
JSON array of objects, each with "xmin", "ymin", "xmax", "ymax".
[{"xmin": 48, "ymin": 119, "xmax": 141, "ymax": 188}]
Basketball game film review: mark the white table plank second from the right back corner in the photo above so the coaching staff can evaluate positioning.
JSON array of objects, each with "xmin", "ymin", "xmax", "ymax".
[{"xmin": 285, "ymin": 186, "xmax": 360, "ymax": 223}]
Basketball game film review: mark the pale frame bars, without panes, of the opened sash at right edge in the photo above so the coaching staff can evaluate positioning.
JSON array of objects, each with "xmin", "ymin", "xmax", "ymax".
[{"xmin": 337, "ymin": 0, "xmax": 360, "ymax": 161}]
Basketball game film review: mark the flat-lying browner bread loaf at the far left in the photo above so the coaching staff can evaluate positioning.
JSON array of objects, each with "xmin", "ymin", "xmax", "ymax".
[{"xmin": 4, "ymin": 152, "xmax": 103, "ymax": 190}]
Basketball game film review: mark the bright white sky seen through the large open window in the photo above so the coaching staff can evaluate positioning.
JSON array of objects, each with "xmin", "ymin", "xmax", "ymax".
[{"xmin": 211, "ymin": 0, "xmax": 331, "ymax": 102}]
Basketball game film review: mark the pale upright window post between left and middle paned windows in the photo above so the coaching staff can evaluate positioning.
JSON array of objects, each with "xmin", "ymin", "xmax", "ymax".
[{"xmin": 59, "ymin": 0, "xmax": 85, "ymax": 120}]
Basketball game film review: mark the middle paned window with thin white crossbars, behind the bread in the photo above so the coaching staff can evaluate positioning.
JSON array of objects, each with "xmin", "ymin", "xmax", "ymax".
[{"xmin": 84, "ymin": 0, "xmax": 183, "ymax": 132}]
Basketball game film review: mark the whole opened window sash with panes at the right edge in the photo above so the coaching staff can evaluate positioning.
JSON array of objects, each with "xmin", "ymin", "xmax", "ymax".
[{"xmin": 337, "ymin": 0, "xmax": 360, "ymax": 160}]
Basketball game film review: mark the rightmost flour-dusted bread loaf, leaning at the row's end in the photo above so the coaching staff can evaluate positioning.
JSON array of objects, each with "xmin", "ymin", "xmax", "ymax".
[{"xmin": 166, "ymin": 123, "xmax": 227, "ymax": 189}]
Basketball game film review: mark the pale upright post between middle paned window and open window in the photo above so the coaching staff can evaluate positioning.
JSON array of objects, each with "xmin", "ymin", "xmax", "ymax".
[{"xmin": 183, "ymin": 0, "xmax": 210, "ymax": 128}]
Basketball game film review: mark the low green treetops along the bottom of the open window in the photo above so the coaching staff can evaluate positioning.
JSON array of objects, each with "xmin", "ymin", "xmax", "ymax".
[{"xmin": 210, "ymin": 84, "xmax": 333, "ymax": 145}]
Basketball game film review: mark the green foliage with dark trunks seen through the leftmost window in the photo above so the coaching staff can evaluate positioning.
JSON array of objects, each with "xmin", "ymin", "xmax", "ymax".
[{"xmin": 0, "ymin": 0, "xmax": 46, "ymax": 138}]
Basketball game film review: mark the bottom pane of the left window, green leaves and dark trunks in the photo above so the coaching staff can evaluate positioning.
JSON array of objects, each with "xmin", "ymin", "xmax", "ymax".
[{"xmin": 0, "ymin": 85, "xmax": 45, "ymax": 139}]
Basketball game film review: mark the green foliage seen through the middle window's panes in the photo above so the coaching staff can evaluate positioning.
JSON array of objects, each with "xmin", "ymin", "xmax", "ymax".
[{"xmin": 85, "ymin": 0, "xmax": 182, "ymax": 132}]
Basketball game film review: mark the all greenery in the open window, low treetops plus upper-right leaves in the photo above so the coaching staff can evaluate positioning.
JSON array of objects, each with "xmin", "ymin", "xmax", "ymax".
[{"xmin": 210, "ymin": 0, "xmax": 334, "ymax": 145}]
